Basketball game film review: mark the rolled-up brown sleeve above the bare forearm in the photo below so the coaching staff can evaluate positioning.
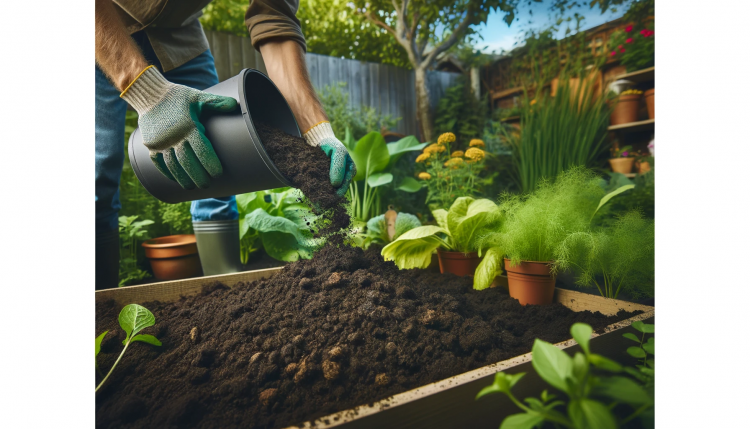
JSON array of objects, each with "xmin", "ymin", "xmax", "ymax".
[{"xmin": 245, "ymin": 0, "xmax": 307, "ymax": 52}]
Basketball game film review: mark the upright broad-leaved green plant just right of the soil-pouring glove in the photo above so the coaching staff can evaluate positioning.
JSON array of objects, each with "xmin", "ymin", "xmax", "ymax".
[{"xmin": 343, "ymin": 129, "xmax": 427, "ymax": 222}]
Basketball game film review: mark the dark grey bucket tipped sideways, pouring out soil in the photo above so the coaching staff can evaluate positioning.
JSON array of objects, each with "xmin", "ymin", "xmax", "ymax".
[{"xmin": 128, "ymin": 69, "xmax": 301, "ymax": 203}]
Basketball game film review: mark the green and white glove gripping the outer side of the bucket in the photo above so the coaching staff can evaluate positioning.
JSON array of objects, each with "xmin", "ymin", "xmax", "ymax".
[{"xmin": 120, "ymin": 66, "xmax": 237, "ymax": 189}]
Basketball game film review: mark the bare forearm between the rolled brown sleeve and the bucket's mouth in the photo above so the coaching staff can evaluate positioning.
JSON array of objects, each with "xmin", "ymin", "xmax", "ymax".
[{"xmin": 260, "ymin": 39, "xmax": 328, "ymax": 133}]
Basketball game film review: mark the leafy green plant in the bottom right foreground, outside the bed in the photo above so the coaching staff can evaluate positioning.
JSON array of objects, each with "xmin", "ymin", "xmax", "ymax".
[{"xmin": 476, "ymin": 323, "xmax": 654, "ymax": 429}]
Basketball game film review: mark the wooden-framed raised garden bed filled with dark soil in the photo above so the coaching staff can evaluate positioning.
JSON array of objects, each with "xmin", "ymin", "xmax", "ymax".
[{"xmin": 96, "ymin": 247, "xmax": 653, "ymax": 428}]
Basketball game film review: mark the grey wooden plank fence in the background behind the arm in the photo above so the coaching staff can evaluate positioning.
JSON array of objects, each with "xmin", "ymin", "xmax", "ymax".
[{"xmin": 206, "ymin": 31, "xmax": 461, "ymax": 135}]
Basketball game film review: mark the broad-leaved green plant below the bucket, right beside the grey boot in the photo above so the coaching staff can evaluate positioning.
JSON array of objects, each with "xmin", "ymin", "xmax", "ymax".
[{"xmin": 237, "ymin": 188, "xmax": 321, "ymax": 264}]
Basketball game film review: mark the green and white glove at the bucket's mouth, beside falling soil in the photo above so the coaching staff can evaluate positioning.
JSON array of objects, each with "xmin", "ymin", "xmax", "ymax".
[{"xmin": 304, "ymin": 121, "xmax": 357, "ymax": 197}]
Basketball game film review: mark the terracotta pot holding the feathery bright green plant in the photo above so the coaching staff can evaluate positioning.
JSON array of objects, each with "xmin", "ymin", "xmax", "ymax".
[{"xmin": 505, "ymin": 258, "xmax": 555, "ymax": 305}]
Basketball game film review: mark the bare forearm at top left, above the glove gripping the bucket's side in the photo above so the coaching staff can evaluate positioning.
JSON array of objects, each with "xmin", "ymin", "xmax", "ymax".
[{"xmin": 95, "ymin": 0, "xmax": 148, "ymax": 91}]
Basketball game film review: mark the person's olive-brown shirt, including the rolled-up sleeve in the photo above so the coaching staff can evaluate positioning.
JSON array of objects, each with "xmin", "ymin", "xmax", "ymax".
[{"xmin": 112, "ymin": 0, "xmax": 307, "ymax": 72}]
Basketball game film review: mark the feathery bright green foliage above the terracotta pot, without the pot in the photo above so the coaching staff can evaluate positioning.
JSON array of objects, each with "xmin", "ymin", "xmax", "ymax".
[{"xmin": 474, "ymin": 167, "xmax": 633, "ymax": 290}]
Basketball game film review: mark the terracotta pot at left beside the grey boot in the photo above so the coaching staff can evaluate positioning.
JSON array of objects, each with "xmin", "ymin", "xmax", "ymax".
[{"xmin": 143, "ymin": 234, "xmax": 202, "ymax": 280}]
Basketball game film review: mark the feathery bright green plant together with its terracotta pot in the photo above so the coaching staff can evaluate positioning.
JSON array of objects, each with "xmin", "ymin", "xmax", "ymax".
[{"xmin": 474, "ymin": 167, "xmax": 633, "ymax": 305}]
